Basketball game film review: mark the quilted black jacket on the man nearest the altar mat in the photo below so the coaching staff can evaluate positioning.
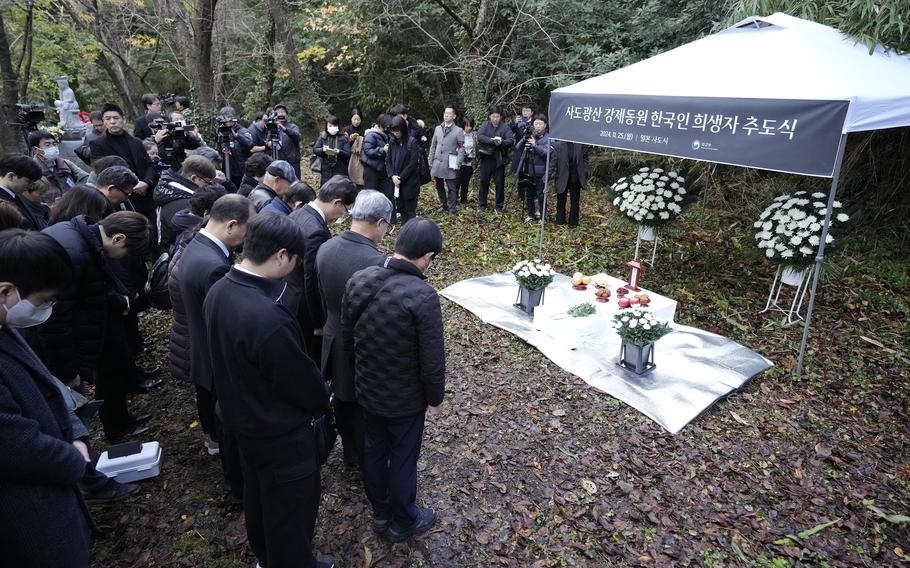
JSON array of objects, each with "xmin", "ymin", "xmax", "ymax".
[{"xmin": 341, "ymin": 257, "xmax": 445, "ymax": 418}]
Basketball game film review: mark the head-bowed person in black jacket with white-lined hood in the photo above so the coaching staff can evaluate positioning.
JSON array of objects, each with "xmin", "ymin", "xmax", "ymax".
[{"xmin": 154, "ymin": 156, "xmax": 215, "ymax": 250}]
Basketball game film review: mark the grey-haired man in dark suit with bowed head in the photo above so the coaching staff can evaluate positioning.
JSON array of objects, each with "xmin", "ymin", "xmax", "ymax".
[{"xmin": 316, "ymin": 189, "xmax": 392, "ymax": 465}]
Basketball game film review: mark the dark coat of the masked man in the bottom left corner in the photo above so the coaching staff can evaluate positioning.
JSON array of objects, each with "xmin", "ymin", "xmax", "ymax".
[{"xmin": 0, "ymin": 327, "xmax": 92, "ymax": 567}]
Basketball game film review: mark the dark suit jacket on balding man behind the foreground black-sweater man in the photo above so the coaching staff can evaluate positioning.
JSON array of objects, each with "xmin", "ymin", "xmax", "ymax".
[{"xmin": 180, "ymin": 233, "xmax": 230, "ymax": 392}]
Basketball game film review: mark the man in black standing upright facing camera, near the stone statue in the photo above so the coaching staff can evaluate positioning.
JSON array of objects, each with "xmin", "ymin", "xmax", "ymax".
[{"xmin": 89, "ymin": 103, "xmax": 158, "ymax": 253}]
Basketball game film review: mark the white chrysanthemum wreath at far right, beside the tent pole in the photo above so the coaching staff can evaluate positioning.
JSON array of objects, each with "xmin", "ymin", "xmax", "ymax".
[{"xmin": 753, "ymin": 191, "xmax": 850, "ymax": 272}]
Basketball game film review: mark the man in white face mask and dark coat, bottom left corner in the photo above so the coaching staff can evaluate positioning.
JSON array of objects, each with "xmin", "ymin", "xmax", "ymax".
[{"xmin": 0, "ymin": 229, "xmax": 93, "ymax": 568}]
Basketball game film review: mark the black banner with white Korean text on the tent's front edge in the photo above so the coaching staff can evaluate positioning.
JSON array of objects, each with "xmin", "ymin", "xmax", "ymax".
[{"xmin": 550, "ymin": 91, "xmax": 850, "ymax": 177}]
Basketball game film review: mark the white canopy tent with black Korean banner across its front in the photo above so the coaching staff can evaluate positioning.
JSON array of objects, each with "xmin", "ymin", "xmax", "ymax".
[{"xmin": 541, "ymin": 13, "xmax": 910, "ymax": 375}]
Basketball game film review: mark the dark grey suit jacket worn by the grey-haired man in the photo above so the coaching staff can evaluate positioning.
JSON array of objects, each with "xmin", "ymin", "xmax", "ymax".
[{"xmin": 316, "ymin": 231, "xmax": 385, "ymax": 402}]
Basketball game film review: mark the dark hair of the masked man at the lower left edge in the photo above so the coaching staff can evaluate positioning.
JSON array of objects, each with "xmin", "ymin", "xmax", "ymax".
[{"xmin": 0, "ymin": 229, "xmax": 73, "ymax": 298}]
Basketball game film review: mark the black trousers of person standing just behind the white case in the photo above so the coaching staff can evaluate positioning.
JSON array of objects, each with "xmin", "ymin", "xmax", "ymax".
[{"xmin": 95, "ymin": 314, "xmax": 134, "ymax": 438}]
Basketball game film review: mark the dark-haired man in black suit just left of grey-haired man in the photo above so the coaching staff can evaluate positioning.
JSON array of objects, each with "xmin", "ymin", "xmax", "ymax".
[{"xmin": 286, "ymin": 173, "xmax": 357, "ymax": 361}]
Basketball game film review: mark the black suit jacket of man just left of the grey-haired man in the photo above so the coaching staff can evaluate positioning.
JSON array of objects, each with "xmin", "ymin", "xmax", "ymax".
[{"xmin": 285, "ymin": 205, "xmax": 332, "ymax": 332}]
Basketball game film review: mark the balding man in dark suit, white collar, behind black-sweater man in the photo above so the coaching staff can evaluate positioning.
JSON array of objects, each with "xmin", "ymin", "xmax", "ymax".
[{"xmin": 179, "ymin": 194, "xmax": 255, "ymax": 498}]
